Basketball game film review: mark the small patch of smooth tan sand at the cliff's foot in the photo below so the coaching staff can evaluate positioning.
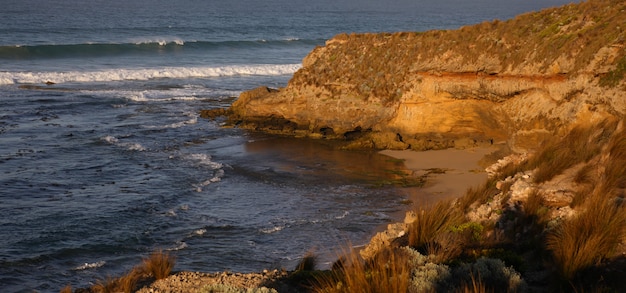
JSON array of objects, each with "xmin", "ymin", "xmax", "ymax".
[{"xmin": 381, "ymin": 147, "xmax": 498, "ymax": 206}]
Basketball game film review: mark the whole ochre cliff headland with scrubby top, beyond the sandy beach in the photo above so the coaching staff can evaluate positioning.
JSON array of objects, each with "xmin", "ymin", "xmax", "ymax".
[{"xmin": 229, "ymin": 0, "xmax": 626, "ymax": 151}]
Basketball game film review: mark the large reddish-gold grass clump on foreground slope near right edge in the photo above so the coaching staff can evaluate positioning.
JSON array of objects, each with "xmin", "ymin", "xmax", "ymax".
[{"xmin": 546, "ymin": 193, "xmax": 626, "ymax": 280}]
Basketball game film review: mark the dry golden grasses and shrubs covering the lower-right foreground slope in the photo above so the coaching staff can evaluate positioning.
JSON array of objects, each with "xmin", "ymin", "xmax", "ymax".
[{"xmin": 306, "ymin": 120, "xmax": 626, "ymax": 292}]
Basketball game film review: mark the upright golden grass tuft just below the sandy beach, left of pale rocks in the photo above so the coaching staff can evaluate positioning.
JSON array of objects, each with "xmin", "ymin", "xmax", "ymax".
[{"xmin": 408, "ymin": 201, "xmax": 464, "ymax": 251}]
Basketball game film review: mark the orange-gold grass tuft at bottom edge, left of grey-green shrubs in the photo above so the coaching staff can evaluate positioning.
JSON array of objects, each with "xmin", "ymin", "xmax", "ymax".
[{"xmin": 313, "ymin": 249, "xmax": 411, "ymax": 293}]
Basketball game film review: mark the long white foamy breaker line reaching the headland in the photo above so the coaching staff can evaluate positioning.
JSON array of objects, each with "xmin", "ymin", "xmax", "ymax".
[{"xmin": 0, "ymin": 64, "xmax": 302, "ymax": 85}]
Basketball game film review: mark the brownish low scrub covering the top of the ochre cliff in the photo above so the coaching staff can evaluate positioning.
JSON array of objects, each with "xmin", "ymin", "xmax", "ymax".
[{"xmin": 290, "ymin": 0, "xmax": 626, "ymax": 104}]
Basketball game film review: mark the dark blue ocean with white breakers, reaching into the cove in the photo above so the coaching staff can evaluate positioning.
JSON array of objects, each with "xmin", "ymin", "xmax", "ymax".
[{"xmin": 0, "ymin": 0, "xmax": 567, "ymax": 292}]
